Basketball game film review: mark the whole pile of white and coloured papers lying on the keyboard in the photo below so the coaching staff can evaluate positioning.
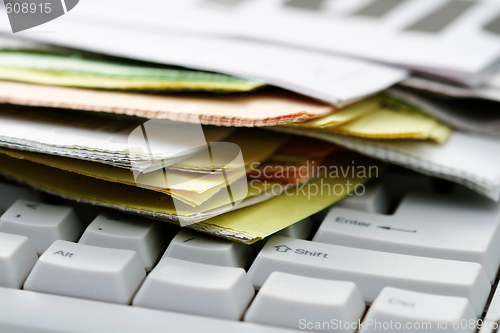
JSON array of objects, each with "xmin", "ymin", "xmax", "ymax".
[{"xmin": 0, "ymin": 0, "xmax": 500, "ymax": 243}]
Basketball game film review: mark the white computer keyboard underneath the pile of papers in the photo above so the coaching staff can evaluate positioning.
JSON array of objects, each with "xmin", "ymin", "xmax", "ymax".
[{"xmin": 0, "ymin": 169, "xmax": 500, "ymax": 333}]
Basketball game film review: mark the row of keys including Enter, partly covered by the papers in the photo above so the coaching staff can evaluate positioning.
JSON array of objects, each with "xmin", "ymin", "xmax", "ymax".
[{"xmin": 4, "ymin": 176, "xmax": 500, "ymax": 282}]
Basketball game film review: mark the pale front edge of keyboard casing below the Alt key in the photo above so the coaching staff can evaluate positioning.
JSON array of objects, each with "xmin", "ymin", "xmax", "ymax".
[{"xmin": 0, "ymin": 287, "xmax": 290, "ymax": 333}]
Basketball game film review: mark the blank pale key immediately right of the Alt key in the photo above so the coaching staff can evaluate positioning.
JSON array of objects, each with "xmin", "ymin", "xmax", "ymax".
[{"xmin": 133, "ymin": 258, "xmax": 255, "ymax": 320}]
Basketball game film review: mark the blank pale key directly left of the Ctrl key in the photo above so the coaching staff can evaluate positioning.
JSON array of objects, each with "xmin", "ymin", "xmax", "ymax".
[{"xmin": 245, "ymin": 272, "xmax": 365, "ymax": 333}]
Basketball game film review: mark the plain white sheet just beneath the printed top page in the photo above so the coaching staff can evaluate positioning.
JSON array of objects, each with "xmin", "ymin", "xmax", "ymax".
[{"xmin": 0, "ymin": 7, "xmax": 407, "ymax": 106}]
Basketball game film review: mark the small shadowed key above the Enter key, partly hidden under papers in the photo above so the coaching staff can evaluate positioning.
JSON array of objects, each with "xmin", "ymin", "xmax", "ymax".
[{"xmin": 333, "ymin": 182, "xmax": 391, "ymax": 214}]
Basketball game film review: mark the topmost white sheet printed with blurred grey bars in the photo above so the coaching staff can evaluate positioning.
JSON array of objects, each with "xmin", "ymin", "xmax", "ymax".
[{"xmin": 67, "ymin": 0, "xmax": 500, "ymax": 85}]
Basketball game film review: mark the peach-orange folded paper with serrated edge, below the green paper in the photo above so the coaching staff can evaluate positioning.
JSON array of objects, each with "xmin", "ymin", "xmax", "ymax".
[{"xmin": 0, "ymin": 81, "xmax": 336, "ymax": 127}]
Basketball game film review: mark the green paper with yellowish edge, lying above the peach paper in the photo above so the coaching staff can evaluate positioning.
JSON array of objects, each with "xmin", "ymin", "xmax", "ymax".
[{"xmin": 0, "ymin": 51, "xmax": 265, "ymax": 93}]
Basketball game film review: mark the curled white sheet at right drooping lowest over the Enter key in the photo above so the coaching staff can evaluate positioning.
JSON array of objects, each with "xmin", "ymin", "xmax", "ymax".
[{"xmin": 274, "ymin": 126, "xmax": 500, "ymax": 202}]
